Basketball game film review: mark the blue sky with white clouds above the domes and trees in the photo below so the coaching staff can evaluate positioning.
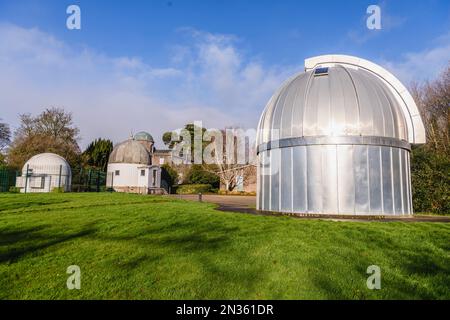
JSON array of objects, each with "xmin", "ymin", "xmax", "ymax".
[{"xmin": 0, "ymin": 0, "xmax": 450, "ymax": 145}]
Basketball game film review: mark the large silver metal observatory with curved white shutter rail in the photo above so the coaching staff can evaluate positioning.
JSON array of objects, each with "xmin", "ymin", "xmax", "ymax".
[{"xmin": 257, "ymin": 55, "xmax": 425, "ymax": 215}]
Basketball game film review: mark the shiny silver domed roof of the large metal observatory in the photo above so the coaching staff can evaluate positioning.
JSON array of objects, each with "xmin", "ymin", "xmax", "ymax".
[{"xmin": 258, "ymin": 56, "xmax": 421, "ymax": 144}]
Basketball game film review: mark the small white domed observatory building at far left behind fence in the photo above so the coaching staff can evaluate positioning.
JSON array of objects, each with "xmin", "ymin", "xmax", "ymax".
[{"xmin": 16, "ymin": 153, "xmax": 72, "ymax": 193}]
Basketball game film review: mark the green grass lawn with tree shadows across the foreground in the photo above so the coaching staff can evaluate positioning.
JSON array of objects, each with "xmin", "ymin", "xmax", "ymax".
[{"xmin": 0, "ymin": 193, "xmax": 450, "ymax": 299}]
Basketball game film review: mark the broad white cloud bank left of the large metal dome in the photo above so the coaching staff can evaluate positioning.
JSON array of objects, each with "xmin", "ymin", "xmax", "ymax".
[{"xmin": 0, "ymin": 24, "xmax": 301, "ymax": 146}]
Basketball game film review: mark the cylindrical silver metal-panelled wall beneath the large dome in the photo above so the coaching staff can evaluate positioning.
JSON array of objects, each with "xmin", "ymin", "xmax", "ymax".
[{"xmin": 257, "ymin": 145, "xmax": 413, "ymax": 215}]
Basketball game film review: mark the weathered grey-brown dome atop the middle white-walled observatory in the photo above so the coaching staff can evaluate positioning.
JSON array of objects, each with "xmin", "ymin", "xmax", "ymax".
[{"xmin": 109, "ymin": 139, "xmax": 151, "ymax": 165}]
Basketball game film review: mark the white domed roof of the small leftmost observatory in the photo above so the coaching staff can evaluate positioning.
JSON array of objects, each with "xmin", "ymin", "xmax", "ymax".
[{"xmin": 22, "ymin": 152, "xmax": 72, "ymax": 175}]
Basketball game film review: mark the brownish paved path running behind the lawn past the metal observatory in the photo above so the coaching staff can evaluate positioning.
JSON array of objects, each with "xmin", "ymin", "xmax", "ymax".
[{"xmin": 171, "ymin": 194, "xmax": 450, "ymax": 223}]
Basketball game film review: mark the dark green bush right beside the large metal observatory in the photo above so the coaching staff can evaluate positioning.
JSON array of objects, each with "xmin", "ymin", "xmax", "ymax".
[{"xmin": 411, "ymin": 146, "xmax": 450, "ymax": 214}]
